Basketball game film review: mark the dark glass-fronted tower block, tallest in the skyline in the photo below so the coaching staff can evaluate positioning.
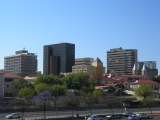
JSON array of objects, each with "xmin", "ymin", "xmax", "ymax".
[{"xmin": 43, "ymin": 43, "xmax": 75, "ymax": 75}]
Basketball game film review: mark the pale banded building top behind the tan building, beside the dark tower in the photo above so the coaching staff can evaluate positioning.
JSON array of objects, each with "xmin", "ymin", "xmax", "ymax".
[{"xmin": 75, "ymin": 57, "xmax": 94, "ymax": 65}]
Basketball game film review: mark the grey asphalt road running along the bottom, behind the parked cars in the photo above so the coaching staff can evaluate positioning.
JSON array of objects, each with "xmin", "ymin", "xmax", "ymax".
[{"xmin": 0, "ymin": 107, "xmax": 160, "ymax": 120}]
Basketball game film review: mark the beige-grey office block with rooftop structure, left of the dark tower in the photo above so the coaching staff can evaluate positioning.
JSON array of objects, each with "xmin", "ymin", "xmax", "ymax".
[{"xmin": 4, "ymin": 50, "xmax": 37, "ymax": 76}]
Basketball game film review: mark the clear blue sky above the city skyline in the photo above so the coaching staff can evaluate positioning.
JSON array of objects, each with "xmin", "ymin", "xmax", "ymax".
[{"xmin": 0, "ymin": 0, "xmax": 160, "ymax": 74}]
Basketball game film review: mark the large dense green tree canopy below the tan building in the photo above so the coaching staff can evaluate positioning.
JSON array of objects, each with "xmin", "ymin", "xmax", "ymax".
[{"xmin": 62, "ymin": 72, "xmax": 90, "ymax": 90}]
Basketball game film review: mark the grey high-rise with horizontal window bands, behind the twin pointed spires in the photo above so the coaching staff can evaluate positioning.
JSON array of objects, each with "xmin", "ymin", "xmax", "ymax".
[{"xmin": 107, "ymin": 47, "xmax": 137, "ymax": 75}]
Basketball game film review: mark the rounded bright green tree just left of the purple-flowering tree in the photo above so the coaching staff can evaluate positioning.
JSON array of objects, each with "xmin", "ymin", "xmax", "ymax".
[{"xmin": 19, "ymin": 87, "xmax": 35, "ymax": 99}]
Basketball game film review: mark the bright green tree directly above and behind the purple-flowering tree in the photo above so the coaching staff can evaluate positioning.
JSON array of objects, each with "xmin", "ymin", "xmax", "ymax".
[{"xmin": 35, "ymin": 83, "xmax": 50, "ymax": 94}]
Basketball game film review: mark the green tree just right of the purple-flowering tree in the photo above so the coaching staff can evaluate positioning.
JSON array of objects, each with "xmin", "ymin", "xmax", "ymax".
[{"xmin": 50, "ymin": 85, "xmax": 66, "ymax": 97}]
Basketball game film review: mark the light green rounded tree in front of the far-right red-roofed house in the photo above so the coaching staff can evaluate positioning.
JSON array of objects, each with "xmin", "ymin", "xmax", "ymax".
[{"xmin": 134, "ymin": 85, "xmax": 153, "ymax": 99}]
